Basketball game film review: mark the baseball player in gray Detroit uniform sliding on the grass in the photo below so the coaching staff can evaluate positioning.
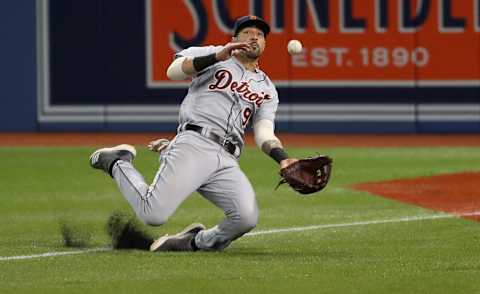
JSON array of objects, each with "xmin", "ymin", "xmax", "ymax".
[{"xmin": 90, "ymin": 16, "xmax": 297, "ymax": 251}]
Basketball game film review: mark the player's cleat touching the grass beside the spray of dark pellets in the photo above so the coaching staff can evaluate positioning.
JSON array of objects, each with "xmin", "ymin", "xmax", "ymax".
[{"xmin": 150, "ymin": 223, "xmax": 205, "ymax": 251}]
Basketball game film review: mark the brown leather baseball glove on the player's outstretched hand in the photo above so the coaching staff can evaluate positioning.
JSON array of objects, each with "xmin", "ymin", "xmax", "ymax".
[{"xmin": 277, "ymin": 155, "xmax": 332, "ymax": 194}]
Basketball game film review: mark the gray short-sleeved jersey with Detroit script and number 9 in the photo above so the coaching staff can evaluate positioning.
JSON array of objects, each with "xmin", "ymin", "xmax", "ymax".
[{"xmin": 176, "ymin": 46, "xmax": 278, "ymax": 145}]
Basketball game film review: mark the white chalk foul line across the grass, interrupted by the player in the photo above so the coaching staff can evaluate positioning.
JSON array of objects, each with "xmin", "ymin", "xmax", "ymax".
[{"xmin": 0, "ymin": 211, "xmax": 480, "ymax": 261}]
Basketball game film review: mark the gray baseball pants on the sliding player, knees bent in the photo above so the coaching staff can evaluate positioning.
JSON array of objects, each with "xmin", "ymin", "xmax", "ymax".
[{"xmin": 112, "ymin": 131, "xmax": 258, "ymax": 250}]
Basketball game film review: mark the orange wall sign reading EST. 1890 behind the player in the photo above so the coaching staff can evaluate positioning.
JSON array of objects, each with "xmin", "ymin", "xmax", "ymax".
[{"xmin": 146, "ymin": 0, "xmax": 480, "ymax": 88}]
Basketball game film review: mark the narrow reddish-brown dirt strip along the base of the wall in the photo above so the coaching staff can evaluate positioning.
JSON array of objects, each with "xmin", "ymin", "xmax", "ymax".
[{"xmin": 0, "ymin": 133, "xmax": 480, "ymax": 147}]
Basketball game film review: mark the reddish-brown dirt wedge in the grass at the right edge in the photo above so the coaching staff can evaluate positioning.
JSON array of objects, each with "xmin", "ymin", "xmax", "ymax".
[{"xmin": 353, "ymin": 172, "xmax": 480, "ymax": 221}]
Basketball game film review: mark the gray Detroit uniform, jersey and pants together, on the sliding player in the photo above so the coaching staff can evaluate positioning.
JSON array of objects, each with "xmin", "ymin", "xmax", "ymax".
[{"xmin": 107, "ymin": 46, "xmax": 278, "ymax": 250}]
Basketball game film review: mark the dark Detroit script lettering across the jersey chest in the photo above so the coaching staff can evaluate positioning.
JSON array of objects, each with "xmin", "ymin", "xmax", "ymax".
[{"xmin": 208, "ymin": 69, "xmax": 272, "ymax": 107}]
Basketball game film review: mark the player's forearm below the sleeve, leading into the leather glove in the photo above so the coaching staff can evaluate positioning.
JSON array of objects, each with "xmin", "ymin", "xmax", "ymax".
[{"xmin": 253, "ymin": 119, "xmax": 297, "ymax": 168}]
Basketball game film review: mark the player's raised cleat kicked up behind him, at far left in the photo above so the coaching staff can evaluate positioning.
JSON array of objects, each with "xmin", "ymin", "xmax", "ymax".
[{"xmin": 90, "ymin": 144, "xmax": 137, "ymax": 177}]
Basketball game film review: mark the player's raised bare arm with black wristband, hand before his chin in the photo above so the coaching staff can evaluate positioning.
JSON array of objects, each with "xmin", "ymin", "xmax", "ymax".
[{"xmin": 167, "ymin": 42, "xmax": 249, "ymax": 81}]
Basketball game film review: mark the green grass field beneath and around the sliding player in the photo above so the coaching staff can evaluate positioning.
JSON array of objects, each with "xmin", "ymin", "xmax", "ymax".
[{"xmin": 0, "ymin": 147, "xmax": 480, "ymax": 294}]
